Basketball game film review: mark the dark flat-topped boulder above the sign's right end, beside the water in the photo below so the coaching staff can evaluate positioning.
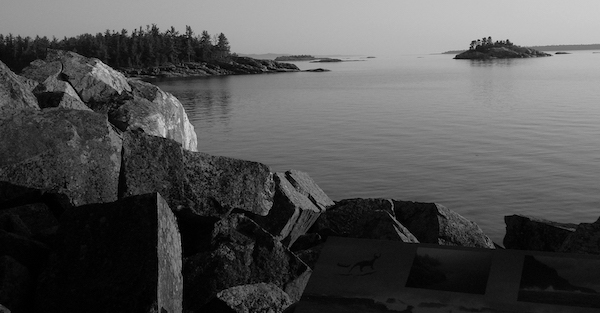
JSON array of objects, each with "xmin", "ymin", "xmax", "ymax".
[{"xmin": 503, "ymin": 215, "xmax": 577, "ymax": 252}]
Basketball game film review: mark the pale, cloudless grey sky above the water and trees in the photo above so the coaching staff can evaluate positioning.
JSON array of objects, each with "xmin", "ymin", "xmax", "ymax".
[{"xmin": 0, "ymin": 0, "xmax": 600, "ymax": 56}]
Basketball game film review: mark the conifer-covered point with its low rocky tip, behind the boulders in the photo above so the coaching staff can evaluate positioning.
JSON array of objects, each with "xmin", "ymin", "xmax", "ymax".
[{"xmin": 0, "ymin": 24, "xmax": 299, "ymax": 77}]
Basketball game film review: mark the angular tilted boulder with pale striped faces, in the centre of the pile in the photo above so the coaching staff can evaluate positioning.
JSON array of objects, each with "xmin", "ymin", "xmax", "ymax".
[{"xmin": 253, "ymin": 170, "xmax": 334, "ymax": 247}]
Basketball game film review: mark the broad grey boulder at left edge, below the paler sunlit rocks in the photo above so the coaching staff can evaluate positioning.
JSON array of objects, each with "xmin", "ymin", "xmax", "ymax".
[{"xmin": 0, "ymin": 108, "xmax": 122, "ymax": 205}]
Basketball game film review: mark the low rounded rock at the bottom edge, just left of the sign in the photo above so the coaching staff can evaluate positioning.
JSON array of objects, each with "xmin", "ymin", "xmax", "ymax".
[{"xmin": 205, "ymin": 283, "xmax": 292, "ymax": 313}]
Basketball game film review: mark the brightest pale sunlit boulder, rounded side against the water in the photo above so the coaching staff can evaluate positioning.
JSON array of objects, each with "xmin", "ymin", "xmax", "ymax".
[{"xmin": 109, "ymin": 79, "xmax": 198, "ymax": 151}]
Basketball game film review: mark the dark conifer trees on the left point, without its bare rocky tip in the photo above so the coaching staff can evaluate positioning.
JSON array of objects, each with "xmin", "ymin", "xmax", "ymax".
[{"xmin": 0, "ymin": 24, "xmax": 231, "ymax": 72}]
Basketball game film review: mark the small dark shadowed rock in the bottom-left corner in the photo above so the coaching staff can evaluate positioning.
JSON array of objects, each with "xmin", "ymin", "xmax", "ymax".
[{"xmin": 0, "ymin": 255, "xmax": 33, "ymax": 312}]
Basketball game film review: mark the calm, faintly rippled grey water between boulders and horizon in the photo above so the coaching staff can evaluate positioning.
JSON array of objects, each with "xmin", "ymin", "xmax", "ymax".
[{"xmin": 155, "ymin": 51, "xmax": 600, "ymax": 242}]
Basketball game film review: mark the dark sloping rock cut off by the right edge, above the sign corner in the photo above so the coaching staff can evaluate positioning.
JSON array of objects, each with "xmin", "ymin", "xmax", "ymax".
[{"xmin": 559, "ymin": 219, "xmax": 600, "ymax": 254}]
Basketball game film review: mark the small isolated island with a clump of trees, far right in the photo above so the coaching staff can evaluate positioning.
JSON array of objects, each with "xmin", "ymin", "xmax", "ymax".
[{"xmin": 454, "ymin": 37, "xmax": 551, "ymax": 60}]
